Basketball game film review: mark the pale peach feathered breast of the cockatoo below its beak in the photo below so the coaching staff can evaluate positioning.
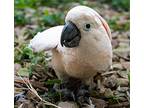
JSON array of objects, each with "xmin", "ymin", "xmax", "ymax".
[{"xmin": 63, "ymin": 48, "xmax": 112, "ymax": 78}]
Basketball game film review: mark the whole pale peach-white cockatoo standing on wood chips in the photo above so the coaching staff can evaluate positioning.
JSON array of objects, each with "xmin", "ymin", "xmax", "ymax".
[{"xmin": 29, "ymin": 5, "xmax": 113, "ymax": 105}]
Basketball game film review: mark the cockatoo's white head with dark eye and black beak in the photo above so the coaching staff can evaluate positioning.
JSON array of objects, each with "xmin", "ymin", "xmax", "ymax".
[{"xmin": 61, "ymin": 6, "xmax": 111, "ymax": 48}]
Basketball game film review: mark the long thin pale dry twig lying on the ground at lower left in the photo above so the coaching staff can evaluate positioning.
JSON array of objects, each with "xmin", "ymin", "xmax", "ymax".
[{"xmin": 18, "ymin": 73, "xmax": 61, "ymax": 108}]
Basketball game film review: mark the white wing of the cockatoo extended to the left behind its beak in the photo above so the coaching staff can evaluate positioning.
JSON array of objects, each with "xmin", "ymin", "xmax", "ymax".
[{"xmin": 29, "ymin": 26, "xmax": 63, "ymax": 52}]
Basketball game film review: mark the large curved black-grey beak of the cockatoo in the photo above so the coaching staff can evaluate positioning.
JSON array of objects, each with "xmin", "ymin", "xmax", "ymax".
[{"xmin": 61, "ymin": 22, "xmax": 81, "ymax": 48}]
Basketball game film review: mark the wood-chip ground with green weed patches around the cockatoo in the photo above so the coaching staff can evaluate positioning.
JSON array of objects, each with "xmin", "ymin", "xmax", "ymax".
[{"xmin": 14, "ymin": 0, "xmax": 130, "ymax": 108}]
